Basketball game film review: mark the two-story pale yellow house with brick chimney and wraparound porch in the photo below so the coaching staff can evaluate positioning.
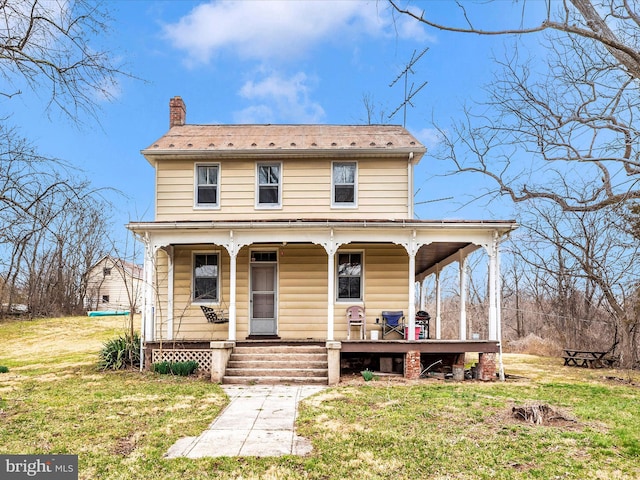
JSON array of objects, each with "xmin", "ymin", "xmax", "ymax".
[{"xmin": 129, "ymin": 97, "xmax": 515, "ymax": 383}]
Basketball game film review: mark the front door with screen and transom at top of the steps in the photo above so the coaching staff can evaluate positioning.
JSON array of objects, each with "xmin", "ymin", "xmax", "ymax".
[{"xmin": 249, "ymin": 252, "xmax": 278, "ymax": 335}]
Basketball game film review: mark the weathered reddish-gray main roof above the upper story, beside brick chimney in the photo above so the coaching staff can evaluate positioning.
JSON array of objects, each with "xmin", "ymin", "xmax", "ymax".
[{"xmin": 142, "ymin": 125, "xmax": 426, "ymax": 162}]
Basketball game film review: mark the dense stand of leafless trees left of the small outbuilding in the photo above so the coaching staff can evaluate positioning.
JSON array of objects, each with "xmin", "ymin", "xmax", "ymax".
[{"xmin": 0, "ymin": 126, "xmax": 109, "ymax": 316}]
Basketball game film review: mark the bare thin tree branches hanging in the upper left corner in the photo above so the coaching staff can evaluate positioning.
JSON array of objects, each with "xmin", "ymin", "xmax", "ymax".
[{"xmin": 0, "ymin": 0, "xmax": 129, "ymax": 121}]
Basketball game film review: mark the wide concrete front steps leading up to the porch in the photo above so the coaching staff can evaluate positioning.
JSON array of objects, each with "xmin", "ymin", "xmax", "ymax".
[{"xmin": 222, "ymin": 344, "xmax": 329, "ymax": 385}]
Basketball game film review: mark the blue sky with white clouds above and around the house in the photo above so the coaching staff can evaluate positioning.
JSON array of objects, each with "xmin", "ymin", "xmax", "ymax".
[{"xmin": 5, "ymin": 0, "xmax": 552, "ymax": 248}]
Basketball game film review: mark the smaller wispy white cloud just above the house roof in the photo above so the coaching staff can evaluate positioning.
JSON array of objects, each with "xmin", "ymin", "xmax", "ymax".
[{"xmin": 235, "ymin": 72, "xmax": 325, "ymax": 123}]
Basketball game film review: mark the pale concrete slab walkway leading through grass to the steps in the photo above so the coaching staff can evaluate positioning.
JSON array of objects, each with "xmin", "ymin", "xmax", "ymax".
[{"xmin": 165, "ymin": 385, "xmax": 326, "ymax": 458}]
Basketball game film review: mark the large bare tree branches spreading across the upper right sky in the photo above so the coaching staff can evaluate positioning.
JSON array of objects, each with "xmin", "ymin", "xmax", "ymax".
[{"xmin": 389, "ymin": 0, "xmax": 640, "ymax": 211}]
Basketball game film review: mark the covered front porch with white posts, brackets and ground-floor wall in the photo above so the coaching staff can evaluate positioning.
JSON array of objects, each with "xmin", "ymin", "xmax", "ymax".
[{"xmin": 129, "ymin": 220, "xmax": 515, "ymax": 381}]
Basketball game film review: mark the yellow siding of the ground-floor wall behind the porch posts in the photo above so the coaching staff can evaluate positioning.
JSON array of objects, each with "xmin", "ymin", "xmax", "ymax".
[{"xmin": 156, "ymin": 244, "xmax": 409, "ymax": 341}]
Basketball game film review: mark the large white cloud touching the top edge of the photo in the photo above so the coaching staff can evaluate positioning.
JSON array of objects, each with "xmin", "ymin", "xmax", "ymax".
[{"xmin": 165, "ymin": 0, "xmax": 427, "ymax": 63}]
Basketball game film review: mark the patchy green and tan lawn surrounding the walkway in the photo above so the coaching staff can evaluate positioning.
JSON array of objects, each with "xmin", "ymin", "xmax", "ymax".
[{"xmin": 0, "ymin": 317, "xmax": 640, "ymax": 480}]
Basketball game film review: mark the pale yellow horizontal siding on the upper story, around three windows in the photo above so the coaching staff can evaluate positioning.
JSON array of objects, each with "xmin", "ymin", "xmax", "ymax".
[{"xmin": 156, "ymin": 159, "xmax": 409, "ymax": 221}]
